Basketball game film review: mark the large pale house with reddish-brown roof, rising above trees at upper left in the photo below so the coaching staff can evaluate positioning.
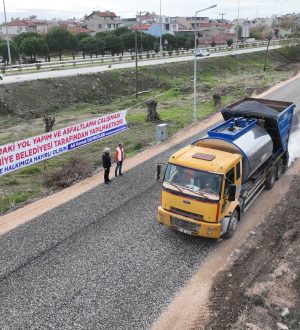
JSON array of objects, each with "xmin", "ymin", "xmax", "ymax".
[{"xmin": 83, "ymin": 10, "xmax": 123, "ymax": 33}]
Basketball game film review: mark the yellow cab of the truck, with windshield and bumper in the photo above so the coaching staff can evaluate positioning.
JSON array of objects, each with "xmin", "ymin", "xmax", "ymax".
[{"xmin": 158, "ymin": 145, "xmax": 241, "ymax": 238}]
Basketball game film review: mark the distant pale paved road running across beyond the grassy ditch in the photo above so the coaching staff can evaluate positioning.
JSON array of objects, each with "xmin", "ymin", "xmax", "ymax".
[{"xmin": 0, "ymin": 46, "xmax": 280, "ymax": 84}]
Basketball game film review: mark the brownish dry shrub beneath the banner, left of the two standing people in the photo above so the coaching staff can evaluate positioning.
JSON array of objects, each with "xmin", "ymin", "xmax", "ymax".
[{"xmin": 44, "ymin": 157, "xmax": 93, "ymax": 188}]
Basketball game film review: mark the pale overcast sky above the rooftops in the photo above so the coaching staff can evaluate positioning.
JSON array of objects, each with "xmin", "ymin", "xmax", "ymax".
[{"xmin": 0, "ymin": 0, "xmax": 300, "ymax": 22}]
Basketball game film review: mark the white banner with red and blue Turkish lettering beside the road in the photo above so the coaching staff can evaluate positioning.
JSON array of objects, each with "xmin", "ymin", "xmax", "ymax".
[{"xmin": 0, "ymin": 110, "xmax": 128, "ymax": 176}]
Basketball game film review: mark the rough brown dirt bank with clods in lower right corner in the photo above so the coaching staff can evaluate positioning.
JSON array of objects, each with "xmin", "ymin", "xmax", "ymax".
[{"xmin": 204, "ymin": 175, "xmax": 300, "ymax": 330}]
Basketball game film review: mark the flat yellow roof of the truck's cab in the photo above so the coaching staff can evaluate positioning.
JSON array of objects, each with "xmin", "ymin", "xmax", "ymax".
[{"xmin": 169, "ymin": 145, "xmax": 241, "ymax": 174}]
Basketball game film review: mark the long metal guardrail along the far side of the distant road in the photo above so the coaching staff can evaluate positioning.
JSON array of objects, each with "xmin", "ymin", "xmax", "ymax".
[{"xmin": 2, "ymin": 40, "xmax": 284, "ymax": 73}]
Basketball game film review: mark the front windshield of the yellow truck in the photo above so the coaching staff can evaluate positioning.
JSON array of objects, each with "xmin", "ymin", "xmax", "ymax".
[{"xmin": 164, "ymin": 164, "xmax": 222, "ymax": 199}]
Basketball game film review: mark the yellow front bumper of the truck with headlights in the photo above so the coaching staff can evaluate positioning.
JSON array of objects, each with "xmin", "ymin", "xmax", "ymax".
[{"xmin": 157, "ymin": 206, "xmax": 221, "ymax": 238}]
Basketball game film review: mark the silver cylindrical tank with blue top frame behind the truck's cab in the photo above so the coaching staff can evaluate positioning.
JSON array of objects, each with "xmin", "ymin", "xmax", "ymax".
[{"xmin": 195, "ymin": 118, "xmax": 273, "ymax": 182}]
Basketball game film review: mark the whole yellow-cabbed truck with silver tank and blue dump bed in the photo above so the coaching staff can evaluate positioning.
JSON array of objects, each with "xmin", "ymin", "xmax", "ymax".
[{"xmin": 157, "ymin": 98, "xmax": 295, "ymax": 238}]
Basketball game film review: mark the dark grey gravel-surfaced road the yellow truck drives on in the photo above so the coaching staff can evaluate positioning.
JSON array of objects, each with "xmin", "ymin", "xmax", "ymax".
[{"xmin": 0, "ymin": 79, "xmax": 300, "ymax": 329}]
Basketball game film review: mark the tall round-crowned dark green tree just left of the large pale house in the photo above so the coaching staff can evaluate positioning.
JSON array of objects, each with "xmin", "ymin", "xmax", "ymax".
[{"xmin": 46, "ymin": 27, "xmax": 72, "ymax": 61}]
